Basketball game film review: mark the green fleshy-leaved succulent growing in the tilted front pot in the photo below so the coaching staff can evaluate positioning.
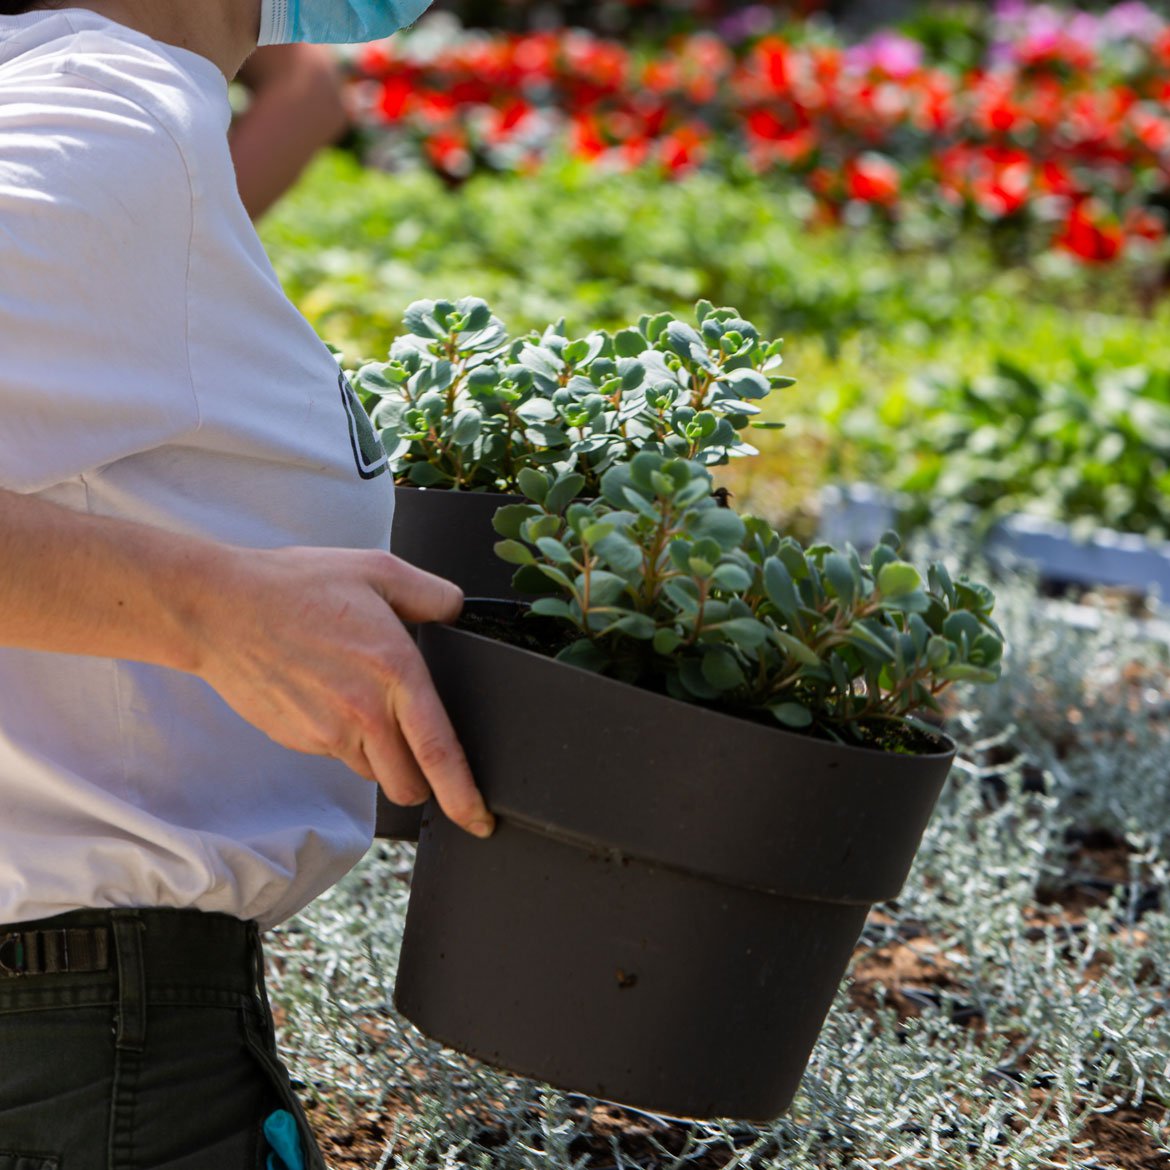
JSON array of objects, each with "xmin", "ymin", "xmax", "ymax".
[{"xmin": 495, "ymin": 451, "xmax": 1004, "ymax": 743}]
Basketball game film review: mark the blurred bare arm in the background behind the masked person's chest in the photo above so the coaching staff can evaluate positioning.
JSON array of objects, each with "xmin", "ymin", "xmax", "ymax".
[{"xmin": 228, "ymin": 44, "xmax": 349, "ymax": 220}]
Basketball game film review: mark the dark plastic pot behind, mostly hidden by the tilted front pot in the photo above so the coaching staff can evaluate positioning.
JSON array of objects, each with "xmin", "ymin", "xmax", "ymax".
[{"xmin": 373, "ymin": 484, "xmax": 524, "ymax": 841}]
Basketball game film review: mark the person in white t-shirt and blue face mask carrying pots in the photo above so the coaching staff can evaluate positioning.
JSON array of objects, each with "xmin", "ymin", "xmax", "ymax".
[{"xmin": 0, "ymin": 0, "xmax": 484, "ymax": 1170}]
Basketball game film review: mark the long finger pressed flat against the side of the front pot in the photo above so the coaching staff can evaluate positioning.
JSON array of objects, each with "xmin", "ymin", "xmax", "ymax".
[{"xmin": 391, "ymin": 659, "xmax": 496, "ymax": 837}]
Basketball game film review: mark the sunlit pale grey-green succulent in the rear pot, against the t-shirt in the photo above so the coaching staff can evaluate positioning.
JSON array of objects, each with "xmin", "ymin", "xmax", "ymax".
[{"xmin": 355, "ymin": 297, "xmax": 792, "ymax": 496}]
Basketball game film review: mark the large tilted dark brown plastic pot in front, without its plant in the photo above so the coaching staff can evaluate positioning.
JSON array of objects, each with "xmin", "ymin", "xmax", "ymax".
[{"xmin": 394, "ymin": 603, "xmax": 955, "ymax": 1121}]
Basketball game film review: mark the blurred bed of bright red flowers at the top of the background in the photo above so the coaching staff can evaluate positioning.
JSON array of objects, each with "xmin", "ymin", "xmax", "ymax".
[{"xmin": 349, "ymin": 0, "xmax": 1170, "ymax": 266}]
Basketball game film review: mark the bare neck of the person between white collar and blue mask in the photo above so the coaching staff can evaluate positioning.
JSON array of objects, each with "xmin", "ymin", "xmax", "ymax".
[{"xmin": 55, "ymin": 0, "xmax": 260, "ymax": 81}]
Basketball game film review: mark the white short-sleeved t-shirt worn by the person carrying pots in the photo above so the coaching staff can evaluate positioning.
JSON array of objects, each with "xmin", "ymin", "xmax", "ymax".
[{"xmin": 0, "ymin": 9, "xmax": 393, "ymax": 927}]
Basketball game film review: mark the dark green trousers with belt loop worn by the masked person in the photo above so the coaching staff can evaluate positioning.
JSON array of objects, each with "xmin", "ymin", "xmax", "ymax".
[{"xmin": 0, "ymin": 910, "xmax": 325, "ymax": 1170}]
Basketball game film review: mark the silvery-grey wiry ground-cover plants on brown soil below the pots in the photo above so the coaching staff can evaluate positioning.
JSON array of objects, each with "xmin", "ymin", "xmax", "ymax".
[{"xmin": 270, "ymin": 563, "xmax": 1170, "ymax": 1170}]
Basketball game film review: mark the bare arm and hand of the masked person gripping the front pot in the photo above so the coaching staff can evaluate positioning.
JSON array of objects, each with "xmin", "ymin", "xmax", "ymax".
[{"xmin": 0, "ymin": 490, "xmax": 493, "ymax": 835}]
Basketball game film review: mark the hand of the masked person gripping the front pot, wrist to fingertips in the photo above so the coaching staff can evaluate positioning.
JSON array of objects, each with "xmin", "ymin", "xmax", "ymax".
[{"xmin": 194, "ymin": 548, "xmax": 495, "ymax": 837}]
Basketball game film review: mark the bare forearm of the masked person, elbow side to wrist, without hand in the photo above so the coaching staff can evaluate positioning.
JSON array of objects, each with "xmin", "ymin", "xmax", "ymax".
[{"xmin": 0, "ymin": 490, "xmax": 217, "ymax": 669}]
